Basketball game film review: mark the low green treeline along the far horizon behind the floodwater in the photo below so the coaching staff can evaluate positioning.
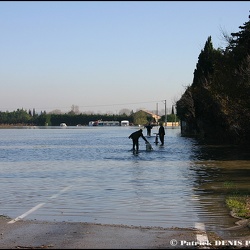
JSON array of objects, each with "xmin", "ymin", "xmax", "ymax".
[{"xmin": 0, "ymin": 109, "xmax": 179, "ymax": 126}]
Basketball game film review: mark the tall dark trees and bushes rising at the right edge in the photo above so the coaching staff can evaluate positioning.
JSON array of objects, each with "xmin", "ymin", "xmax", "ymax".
[{"xmin": 176, "ymin": 12, "xmax": 250, "ymax": 144}]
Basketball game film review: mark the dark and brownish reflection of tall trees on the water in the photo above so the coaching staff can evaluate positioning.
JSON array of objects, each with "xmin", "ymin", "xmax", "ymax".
[{"xmin": 190, "ymin": 141, "xmax": 250, "ymax": 237}]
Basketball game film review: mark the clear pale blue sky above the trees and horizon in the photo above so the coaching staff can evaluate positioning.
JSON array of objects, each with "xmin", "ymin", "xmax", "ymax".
[{"xmin": 0, "ymin": 1, "xmax": 250, "ymax": 114}]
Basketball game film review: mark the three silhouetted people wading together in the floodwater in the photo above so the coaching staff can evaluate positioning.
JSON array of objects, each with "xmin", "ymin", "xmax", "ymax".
[{"xmin": 128, "ymin": 122, "xmax": 165, "ymax": 152}]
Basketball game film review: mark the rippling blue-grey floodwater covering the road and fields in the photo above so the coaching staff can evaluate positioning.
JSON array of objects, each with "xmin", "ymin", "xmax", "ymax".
[{"xmin": 0, "ymin": 127, "xmax": 250, "ymax": 238}]
